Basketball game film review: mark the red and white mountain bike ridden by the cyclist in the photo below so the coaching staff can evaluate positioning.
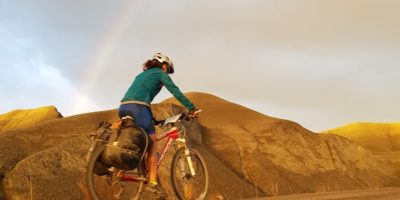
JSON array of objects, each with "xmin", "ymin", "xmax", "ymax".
[{"xmin": 86, "ymin": 111, "xmax": 208, "ymax": 200}]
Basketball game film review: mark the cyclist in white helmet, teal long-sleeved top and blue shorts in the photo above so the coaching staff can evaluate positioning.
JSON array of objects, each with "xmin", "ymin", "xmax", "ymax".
[{"xmin": 119, "ymin": 53, "xmax": 198, "ymax": 197}]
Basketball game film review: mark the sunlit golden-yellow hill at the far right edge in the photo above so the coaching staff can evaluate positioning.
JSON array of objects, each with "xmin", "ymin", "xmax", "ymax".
[{"xmin": 324, "ymin": 122, "xmax": 400, "ymax": 152}]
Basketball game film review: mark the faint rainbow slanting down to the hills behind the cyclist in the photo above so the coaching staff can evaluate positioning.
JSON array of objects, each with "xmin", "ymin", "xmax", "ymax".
[{"xmin": 72, "ymin": 1, "xmax": 135, "ymax": 112}]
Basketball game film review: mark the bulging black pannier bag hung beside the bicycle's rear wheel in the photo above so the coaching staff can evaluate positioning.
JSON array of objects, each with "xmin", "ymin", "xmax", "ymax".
[{"xmin": 102, "ymin": 119, "xmax": 149, "ymax": 170}]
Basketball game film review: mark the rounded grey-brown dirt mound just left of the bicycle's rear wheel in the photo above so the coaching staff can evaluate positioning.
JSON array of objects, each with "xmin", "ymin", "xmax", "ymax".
[{"xmin": 4, "ymin": 137, "xmax": 89, "ymax": 199}]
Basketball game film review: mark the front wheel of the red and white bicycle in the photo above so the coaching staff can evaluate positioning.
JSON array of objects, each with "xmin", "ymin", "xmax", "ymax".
[{"xmin": 171, "ymin": 149, "xmax": 208, "ymax": 200}]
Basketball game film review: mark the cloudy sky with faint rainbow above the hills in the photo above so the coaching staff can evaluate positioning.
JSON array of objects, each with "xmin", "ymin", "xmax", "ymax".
[{"xmin": 0, "ymin": 0, "xmax": 400, "ymax": 132}]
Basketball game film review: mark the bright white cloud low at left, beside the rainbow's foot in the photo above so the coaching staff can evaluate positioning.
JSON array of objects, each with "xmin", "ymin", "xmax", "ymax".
[{"xmin": 0, "ymin": 38, "xmax": 99, "ymax": 115}]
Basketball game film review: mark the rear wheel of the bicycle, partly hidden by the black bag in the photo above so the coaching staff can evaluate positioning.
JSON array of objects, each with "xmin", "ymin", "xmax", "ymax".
[{"xmin": 86, "ymin": 144, "xmax": 144, "ymax": 200}]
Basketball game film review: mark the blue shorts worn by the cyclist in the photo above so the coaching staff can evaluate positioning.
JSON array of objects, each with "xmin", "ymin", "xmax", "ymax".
[{"xmin": 118, "ymin": 103, "xmax": 156, "ymax": 135}]
